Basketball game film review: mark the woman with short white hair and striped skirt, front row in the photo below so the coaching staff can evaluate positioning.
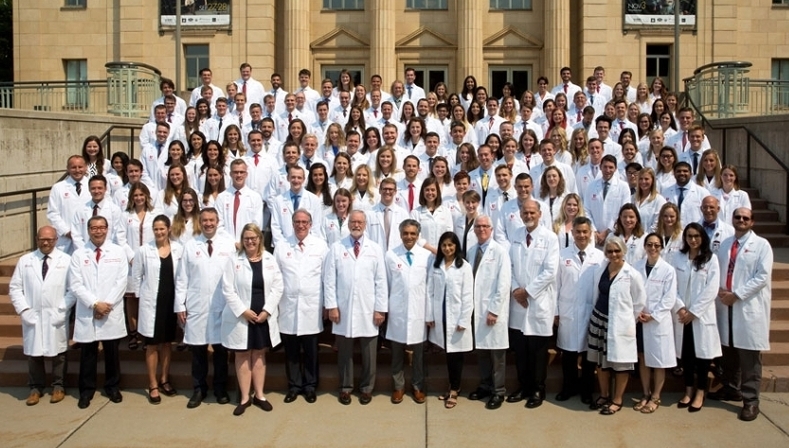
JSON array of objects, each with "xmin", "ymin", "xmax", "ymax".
[{"xmin": 579, "ymin": 236, "xmax": 646, "ymax": 415}]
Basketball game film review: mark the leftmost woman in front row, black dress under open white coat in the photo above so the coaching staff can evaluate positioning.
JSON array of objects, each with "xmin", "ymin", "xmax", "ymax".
[{"xmin": 129, "ymin": 215, "xmax": 183, "ymax": 404}]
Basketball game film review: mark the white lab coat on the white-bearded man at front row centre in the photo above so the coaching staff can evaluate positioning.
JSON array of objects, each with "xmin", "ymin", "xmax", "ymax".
[{"xmin": 323, "ymin": 236, "xmax": 388, "ymax": 338}]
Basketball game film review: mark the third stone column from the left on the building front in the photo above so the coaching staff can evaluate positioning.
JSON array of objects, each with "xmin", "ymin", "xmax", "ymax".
[{"xmin": 449, "ymin": 0, "xmax": 489, "ymax": 92}]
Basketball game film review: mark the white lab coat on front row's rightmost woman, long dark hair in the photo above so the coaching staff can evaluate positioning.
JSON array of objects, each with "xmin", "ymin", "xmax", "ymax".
[{"xmin": 671, "ymin": 253, "xmax": 728, "ymax": 359}]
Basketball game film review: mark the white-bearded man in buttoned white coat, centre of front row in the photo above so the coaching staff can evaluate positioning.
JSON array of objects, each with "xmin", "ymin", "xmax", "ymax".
[{"xmin": 323, "ymin": 210, "xmax": 388, "ymax": 405}]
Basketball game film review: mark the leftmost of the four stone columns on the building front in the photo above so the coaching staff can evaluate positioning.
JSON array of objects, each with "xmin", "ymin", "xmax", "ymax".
[{"xmin": 281, "ymin": 0, "xmax": 310, "ymax": 92}]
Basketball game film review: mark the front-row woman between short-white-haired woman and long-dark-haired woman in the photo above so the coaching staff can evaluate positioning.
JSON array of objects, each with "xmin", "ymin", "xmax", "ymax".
[{"xmin": 633, "ymin": 233, "xmax": 677, "ymax": 414}]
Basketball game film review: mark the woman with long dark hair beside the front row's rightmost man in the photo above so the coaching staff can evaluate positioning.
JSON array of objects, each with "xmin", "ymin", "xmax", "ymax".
[{"xmin": 672, "ymin": 222, "xmax": 721, "ymax": 412}]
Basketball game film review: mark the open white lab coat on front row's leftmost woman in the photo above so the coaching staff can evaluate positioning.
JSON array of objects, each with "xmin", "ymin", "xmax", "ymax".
[{"xmin": 128, "ymin": 241, "xmax": 184, "ymax": 338}]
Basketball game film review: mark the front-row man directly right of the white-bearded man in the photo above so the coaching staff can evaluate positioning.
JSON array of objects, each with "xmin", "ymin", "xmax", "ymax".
[{"xmin": 385, "ymin": 218, "xmax": 430, "ymax": 404}]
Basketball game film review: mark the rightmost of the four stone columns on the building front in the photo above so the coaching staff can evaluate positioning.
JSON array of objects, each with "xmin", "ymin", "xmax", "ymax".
[{"xmin": 538, "ymin": 0, "xmax": 570, "ymax": 82}]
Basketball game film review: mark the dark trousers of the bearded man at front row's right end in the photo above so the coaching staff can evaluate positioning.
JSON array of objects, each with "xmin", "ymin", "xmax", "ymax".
[{"xmin": 721, "ymin": 346, "xmax": 762, "ymax": 406}]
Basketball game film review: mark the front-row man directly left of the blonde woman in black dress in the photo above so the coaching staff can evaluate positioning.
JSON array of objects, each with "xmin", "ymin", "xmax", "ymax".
[{"xmin": 174, "ymin": 207, "xmax": 236, "ymax": 409}]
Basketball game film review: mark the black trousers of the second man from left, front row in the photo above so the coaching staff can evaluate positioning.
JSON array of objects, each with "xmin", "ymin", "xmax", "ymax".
[{"xmin": 79, "ymin": 339, "xmax": 121, "ymax": 398}]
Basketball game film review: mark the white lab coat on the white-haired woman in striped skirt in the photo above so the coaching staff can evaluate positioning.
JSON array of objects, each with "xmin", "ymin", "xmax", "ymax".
[{"xmin": 578, "ymin": 261, "xmax": 647, "ymax": 363}]
